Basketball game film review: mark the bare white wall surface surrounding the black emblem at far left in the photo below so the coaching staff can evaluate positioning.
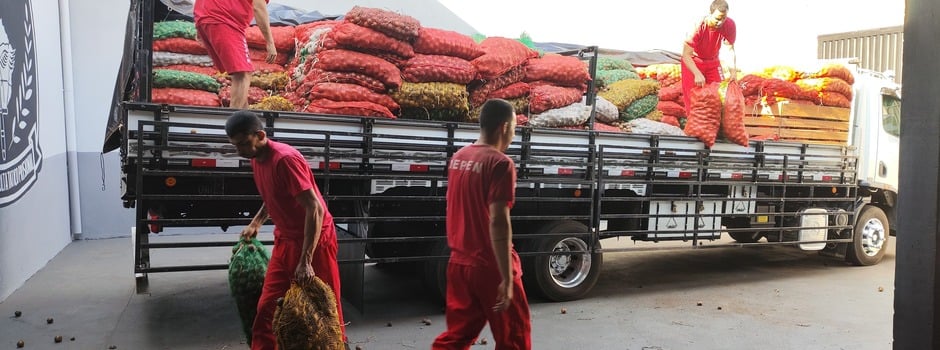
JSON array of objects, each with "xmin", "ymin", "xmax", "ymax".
[{"xmin": 0, "ymin": 0, "xmax": 71, "ymax": 301}]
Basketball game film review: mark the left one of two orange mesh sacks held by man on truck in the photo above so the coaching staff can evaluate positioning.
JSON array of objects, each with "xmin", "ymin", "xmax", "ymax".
[{"xmin": 685, "ymin": 83, "xmax": 721, "ymax": 148}]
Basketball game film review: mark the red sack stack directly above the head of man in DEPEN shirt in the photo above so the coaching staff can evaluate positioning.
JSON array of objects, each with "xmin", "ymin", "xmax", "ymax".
[{"xmin": 470, "ymin": 37, "xmax": 540, "ymax": 120}]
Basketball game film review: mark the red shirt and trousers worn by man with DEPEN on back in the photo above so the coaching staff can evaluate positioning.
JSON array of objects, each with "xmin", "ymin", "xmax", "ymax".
[{"xmin": 432, "ymin": 145, "xmax": 532, "ymax": 349}]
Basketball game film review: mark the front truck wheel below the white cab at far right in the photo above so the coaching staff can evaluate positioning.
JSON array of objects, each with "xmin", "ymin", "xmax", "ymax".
[{"xmin": 845, "ymin": 205, "xmax": 891, "ymax": 266}]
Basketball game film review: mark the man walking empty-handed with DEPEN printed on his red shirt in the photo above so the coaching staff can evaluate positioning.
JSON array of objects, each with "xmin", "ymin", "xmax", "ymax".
[{"xmin": 432, "ymin": 99, "xmax": 531, "ymax": 349}]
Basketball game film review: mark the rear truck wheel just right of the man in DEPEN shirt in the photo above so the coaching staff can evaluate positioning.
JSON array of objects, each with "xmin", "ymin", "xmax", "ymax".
[{"xmin": 523, "ymin": 221, "xmax": 604, "ymax": 301}]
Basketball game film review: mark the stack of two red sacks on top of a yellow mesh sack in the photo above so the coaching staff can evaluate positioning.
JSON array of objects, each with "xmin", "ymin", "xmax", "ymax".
[{"xmin": 392, "ymin": 28, "xmax": 484, "ymax": 121}]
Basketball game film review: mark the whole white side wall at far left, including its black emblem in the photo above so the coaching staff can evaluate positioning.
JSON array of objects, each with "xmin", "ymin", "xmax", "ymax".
[{"xmin": 0, "ymin": 0, "xmax": 71, "ymax": 301}]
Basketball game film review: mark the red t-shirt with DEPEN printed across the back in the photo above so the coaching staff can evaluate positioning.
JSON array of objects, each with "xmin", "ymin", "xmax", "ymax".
[{"xmin": 447, "ymin": 144, "xmax": 521, "ymax": 276}]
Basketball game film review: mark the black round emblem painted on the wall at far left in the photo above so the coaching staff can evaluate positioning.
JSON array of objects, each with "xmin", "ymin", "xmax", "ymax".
[{"xmin": 0, "ymin": 0, "xmax": 42, "ymax": 208}]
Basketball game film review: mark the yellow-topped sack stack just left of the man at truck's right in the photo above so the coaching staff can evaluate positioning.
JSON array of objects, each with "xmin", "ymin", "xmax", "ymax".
[{"xmin": 637, "ymin": 64, "xmax": 687, "ymax": 127}]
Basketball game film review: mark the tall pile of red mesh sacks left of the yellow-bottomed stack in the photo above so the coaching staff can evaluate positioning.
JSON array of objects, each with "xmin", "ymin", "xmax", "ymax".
[{"xmin": 288, "ymin": 6, "xmax": 421, "ymax": 118}]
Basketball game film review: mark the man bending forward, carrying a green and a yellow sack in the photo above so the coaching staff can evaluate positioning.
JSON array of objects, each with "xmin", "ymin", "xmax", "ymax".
[{"xmin": 225, "ymin": 111, "xmax": 346, "ymax": 350}]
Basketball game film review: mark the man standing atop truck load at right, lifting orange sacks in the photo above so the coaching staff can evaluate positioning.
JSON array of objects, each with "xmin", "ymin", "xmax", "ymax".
[{"xmin": 682, "ymin": 0, "xmax": 737, "ymax": 112}]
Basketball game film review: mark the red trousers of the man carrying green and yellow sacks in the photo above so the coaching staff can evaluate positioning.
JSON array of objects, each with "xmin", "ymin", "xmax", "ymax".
[{"xmin": 251, "ymin": 229, "xmax": 346, "ymax": 350}]
